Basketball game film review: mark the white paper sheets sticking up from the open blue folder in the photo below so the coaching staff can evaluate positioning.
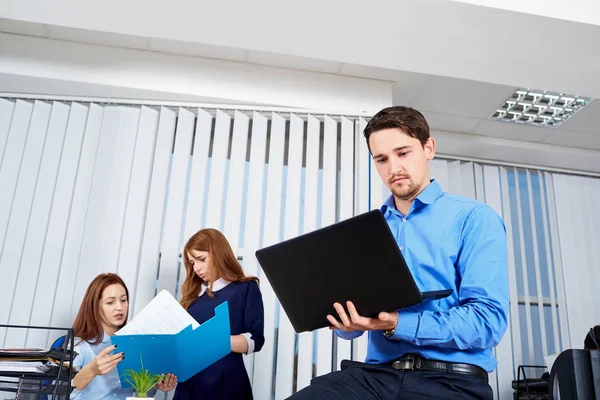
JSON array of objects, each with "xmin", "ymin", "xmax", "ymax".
[{"xmin": 115, "ymin": 290, "xmax": 200, "ymax": 335}]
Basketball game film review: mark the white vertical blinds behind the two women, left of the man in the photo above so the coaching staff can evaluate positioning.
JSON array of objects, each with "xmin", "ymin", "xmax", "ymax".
[{"xmin": 0, "ymin": 99, "xmax": 369, "ymax": 399}]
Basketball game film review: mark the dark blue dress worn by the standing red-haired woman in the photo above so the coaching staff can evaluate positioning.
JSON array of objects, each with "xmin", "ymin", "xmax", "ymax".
[{"xmin": 174, "ymin": 281, "xmax": 265, "ymax": 400}]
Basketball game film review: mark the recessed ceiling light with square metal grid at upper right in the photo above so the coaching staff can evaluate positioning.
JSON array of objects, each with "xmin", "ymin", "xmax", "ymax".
[{"xmin": 489, "ymin": 89, "xmax": 593, "ymax": 128}]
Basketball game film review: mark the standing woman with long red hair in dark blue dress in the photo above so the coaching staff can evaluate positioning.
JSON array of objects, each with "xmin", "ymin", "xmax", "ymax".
[{"xmin": 174, "ymin": 229, "xmax": 265, "ymax": 400}]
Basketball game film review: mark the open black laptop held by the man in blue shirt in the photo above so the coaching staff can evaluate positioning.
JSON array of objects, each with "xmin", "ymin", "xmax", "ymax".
[{"xmin": 256, "ymin": 210, "xmax": 452, "ymax": 333}]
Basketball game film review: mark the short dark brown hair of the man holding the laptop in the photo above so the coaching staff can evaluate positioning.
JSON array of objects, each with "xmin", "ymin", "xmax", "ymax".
[{"xmin": 363, "ymin": 106, "xmax": 429, "ymax": 151}]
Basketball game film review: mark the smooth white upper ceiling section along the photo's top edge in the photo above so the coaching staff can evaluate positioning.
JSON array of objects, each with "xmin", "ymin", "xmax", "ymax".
[{"xmin": 0, "ymin": 0, "xmax": 600, "ymax": 97}]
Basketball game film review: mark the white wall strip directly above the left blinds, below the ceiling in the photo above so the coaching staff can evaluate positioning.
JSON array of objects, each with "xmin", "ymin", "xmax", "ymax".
[{"xmin": 0, "ymin": 34, "xmax": 392, "ymax": 114}]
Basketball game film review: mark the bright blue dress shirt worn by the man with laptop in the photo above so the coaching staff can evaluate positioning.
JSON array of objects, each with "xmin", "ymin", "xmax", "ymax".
[{"xmin": 336, "ymin": 180, "xmax": 509, "ymax": 372}]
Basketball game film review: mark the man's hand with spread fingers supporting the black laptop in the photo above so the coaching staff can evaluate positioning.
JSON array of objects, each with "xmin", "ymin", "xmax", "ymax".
[{"xmin": 327, "ymin": 301, "xmax": 398, "ymax": 332}]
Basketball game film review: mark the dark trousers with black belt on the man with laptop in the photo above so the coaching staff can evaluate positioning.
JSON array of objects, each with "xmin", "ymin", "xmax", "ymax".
[{"xmin": 288, "ymin": 360, "xmax": 494, "ymax": 400}]
